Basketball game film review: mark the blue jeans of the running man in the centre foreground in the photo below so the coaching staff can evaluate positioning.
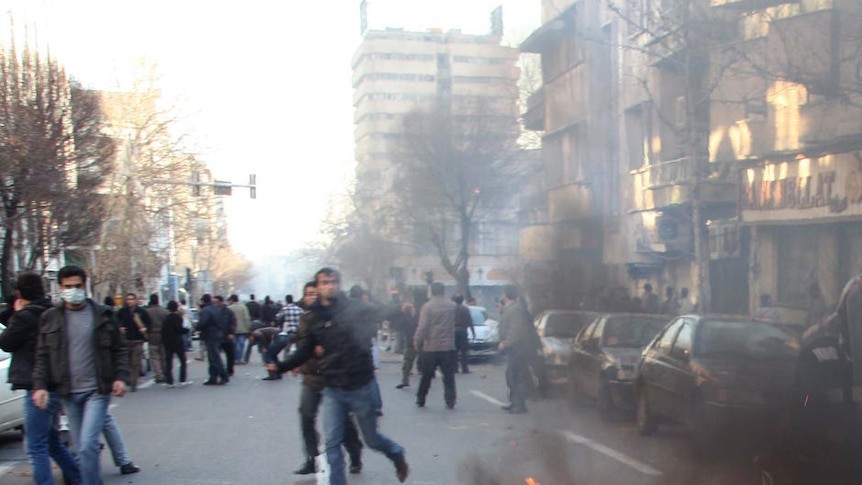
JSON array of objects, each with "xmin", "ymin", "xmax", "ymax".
[{"xmin": 323, "ymin": 383, "xmax": 404, "ymax": 485}]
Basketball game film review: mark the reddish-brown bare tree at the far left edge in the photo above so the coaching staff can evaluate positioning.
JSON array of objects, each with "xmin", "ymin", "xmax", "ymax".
[{"xmin": 0, "ymin": 36, "xmax": 112, "ymax": 294}]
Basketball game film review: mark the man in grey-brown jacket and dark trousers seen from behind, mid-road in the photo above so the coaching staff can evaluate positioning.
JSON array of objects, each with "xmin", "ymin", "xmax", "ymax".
[{"xmin": 413, "ymin": 282, "xmax": 458, "ymax": 409}]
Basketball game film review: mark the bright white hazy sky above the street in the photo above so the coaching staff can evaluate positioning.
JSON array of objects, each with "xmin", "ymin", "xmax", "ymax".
[{"xmin": 5, "ymin": 0, "xmax": 541, "ymax": 260}]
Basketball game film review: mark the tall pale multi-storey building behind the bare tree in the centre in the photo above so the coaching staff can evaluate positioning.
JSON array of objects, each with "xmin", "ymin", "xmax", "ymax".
[{"xmin": 352, "ymin": 13, "xmax": 519, "ymax": 300}]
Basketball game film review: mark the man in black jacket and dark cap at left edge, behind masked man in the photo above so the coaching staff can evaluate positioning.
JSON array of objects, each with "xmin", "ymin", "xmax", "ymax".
[{"xmin": 0, "ymin": 273, "xmax": 81, "ymax": 485}]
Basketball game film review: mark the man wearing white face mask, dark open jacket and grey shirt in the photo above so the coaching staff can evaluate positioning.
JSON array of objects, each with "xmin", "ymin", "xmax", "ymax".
[{"xmin": 32, "ymin": 266, "xmax": 129, "ymax": 485}]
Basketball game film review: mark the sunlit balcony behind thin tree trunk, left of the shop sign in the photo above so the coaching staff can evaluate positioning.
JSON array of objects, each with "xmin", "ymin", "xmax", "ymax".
[{"xmin": 631, "ymin": 157, "xmax": 737, "ymax": 211}]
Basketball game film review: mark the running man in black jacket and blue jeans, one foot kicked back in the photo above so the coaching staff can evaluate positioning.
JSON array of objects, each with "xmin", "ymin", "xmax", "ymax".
[{"xmin": 267, "ymin": 268, "xmax": 409, "ymax": 485}]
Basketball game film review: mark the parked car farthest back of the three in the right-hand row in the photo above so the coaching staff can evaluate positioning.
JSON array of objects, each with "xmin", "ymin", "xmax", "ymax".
[{"xmin": 534, "ymin": 310, "xmax": 599, "ymax": 380}]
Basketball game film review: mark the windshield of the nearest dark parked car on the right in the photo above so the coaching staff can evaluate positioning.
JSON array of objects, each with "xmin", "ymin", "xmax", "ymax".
[{"xmin": 694, "ymin": 320, "xmax": 799, "ymax": 358}]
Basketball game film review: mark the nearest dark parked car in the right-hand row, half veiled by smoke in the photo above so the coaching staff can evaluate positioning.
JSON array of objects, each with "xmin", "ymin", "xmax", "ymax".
[{"xmin": 635, "ymin": 315, "xmax": 799, "ymax": 450}]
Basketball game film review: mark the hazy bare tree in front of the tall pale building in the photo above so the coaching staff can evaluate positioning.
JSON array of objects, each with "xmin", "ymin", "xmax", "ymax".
[{"xmin": 394, "ymin": 97, "xmax": 534, "ymax": 295}]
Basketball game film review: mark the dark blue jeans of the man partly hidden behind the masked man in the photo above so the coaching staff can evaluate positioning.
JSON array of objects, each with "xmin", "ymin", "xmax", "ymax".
[{"xmin": 24, "ymin": 391, "xmax": 81, "ymax": 485}]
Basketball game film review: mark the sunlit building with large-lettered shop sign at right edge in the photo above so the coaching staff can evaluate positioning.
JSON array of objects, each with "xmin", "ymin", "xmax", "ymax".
[{"xmin": 710, "ymin": 0, "xmax": 862, "ymax": 322}]
